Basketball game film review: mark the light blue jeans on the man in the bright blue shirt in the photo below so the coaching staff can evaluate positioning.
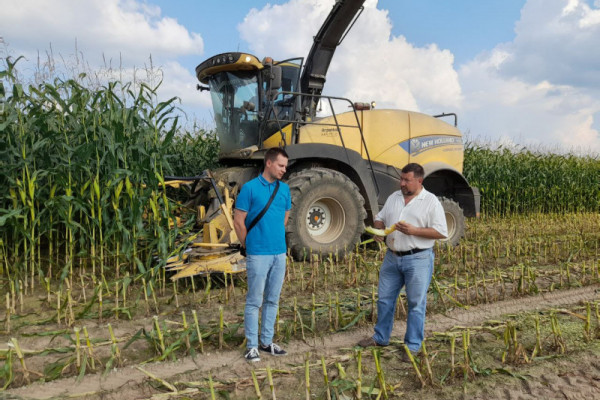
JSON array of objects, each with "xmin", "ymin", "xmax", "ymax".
[{"xmin": 244, "ymin": 253, "xmax": 286, "ymax": 348}]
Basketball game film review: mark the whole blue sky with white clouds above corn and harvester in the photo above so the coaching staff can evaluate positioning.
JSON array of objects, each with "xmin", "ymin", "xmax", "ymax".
[{"xmin": 0, "ymin": 0, "xmax": 600, "ymax": 154}]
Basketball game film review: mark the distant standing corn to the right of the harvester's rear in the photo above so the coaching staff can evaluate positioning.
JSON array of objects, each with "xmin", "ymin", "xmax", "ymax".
[{"xmin": 464, "ymin": 144, "xmax": 600, "ymax": 215}]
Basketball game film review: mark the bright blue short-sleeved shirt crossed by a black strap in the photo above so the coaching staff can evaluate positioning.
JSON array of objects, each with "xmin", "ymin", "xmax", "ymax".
[{"xmin": 235, "ymin": 174, "xmax": 292, "ymax": 255}]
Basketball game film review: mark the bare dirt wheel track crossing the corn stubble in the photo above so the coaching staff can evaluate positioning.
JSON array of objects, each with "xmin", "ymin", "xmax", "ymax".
[{"xmin": 5, "ymin": 285, "xmax": 600, "ymax": 400}]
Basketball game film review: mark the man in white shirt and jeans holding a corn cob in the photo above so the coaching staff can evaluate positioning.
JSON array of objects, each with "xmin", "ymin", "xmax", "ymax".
[{"xmin": 358, "ymin": 163, "xmax": 448, "ymax": 361}]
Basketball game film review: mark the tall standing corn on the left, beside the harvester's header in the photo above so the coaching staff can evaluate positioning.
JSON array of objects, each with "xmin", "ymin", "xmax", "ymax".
[{"xmin": 0, "ymin": 60, "xmax": 205, "ymax": 286}]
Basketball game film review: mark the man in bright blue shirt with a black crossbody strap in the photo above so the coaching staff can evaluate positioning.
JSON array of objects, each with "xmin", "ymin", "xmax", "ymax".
[{"xmin": 234, "ymin": 148, "xmax": 292, "ymax": 362}]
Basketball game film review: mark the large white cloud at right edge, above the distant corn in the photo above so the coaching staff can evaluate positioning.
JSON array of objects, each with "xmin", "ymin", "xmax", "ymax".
[{"xmin": 459, "ymin": 0, "xmax": 600, "ymax": 154}]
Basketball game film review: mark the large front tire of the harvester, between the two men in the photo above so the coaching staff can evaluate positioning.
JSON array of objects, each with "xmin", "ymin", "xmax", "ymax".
[{"xmin": 286, "ymin": 168, "xmax": 367, "ymax": 260}]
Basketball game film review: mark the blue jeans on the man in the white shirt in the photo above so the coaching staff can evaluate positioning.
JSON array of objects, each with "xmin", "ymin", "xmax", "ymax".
[{"xmin": 373, "ymin": 249, "xmax": 433, "ymax": 352}]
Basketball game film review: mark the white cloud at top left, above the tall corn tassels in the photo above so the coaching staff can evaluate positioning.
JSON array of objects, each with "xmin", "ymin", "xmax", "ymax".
[{"xmin": 0, "ymin": 0, "xmax": 204, "ymax": 65}]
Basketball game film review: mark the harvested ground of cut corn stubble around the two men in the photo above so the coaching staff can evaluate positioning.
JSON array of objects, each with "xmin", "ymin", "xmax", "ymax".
[{"xmin": 0, "ymin": 213, "xmax": 600, "ymax": 399}]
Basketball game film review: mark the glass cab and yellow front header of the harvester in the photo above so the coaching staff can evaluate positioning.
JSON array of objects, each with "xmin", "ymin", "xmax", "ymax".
[{"xmin": 165, "ymin": 53, "xmax": 302, "ymax": 279}]
